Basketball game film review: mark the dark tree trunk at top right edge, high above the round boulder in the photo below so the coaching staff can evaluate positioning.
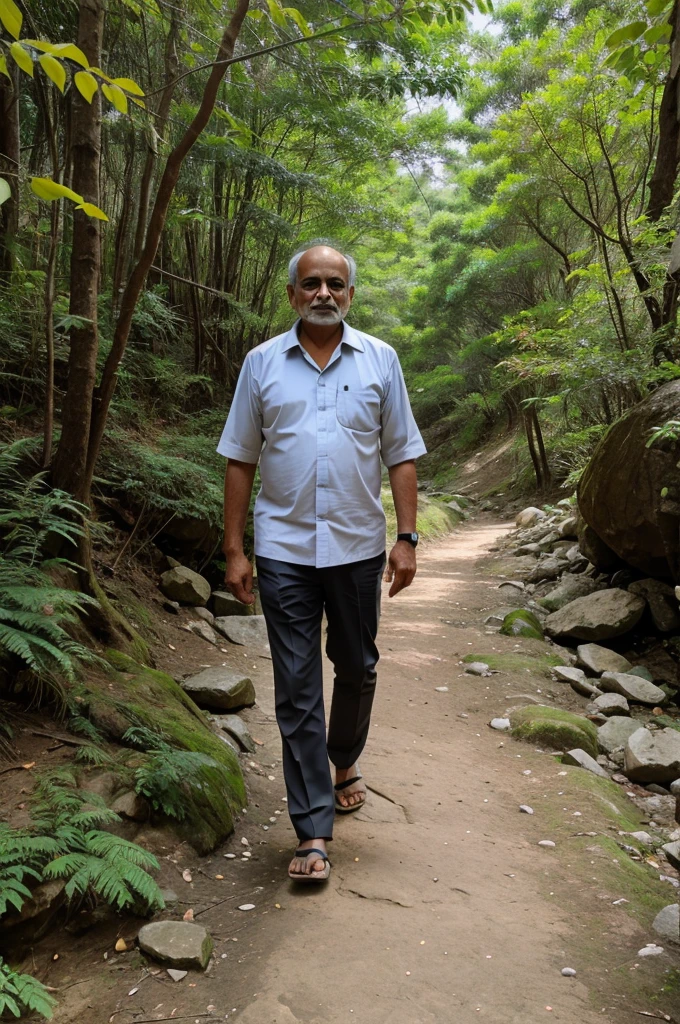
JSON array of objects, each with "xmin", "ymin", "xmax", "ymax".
[{"xmin": 647, "ymin": 0, "xmax": 680, "ymax": 221}]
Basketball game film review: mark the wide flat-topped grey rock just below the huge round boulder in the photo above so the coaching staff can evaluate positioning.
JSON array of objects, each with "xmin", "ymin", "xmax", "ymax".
[{"xmin": 546, "ymin": 588, "xmax": 645, "ymax": 640}]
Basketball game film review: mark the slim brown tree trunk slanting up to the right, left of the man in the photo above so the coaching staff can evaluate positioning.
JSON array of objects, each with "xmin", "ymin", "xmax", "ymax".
[{"xmin": 83, "ymin": 0, "xmax": 250, "ymax": 494}]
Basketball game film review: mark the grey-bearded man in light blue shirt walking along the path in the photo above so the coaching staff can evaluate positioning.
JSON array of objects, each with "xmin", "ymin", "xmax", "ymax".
[{"xmin": 217, "ymin": 246, "xmax": 425, "ymax": 882}]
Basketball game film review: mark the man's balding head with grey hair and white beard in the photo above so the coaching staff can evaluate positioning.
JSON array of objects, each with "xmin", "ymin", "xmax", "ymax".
[{"xmin": 288, "ymin": 246, "xmax": 354, "ymax": 326}]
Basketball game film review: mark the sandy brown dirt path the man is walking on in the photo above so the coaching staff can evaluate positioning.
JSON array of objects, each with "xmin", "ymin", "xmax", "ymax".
[{"xmin": 51, "ymin": 522, "xmax": 671, "ymax": 1024}]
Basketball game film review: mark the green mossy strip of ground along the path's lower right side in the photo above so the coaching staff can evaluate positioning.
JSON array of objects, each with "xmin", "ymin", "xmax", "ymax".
[{"xmin": 522, "ymin": 766, "xmax": 680, "ymax": 1020}]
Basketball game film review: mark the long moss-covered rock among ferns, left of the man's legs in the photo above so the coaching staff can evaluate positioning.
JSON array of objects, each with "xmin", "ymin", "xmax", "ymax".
[{"xmin": 81, "ymin": 650, "xmax": 246, "ymax": 854}]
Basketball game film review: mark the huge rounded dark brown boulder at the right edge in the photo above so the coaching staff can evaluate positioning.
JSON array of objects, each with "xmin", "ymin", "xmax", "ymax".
[{"xmin": 578, "ymin": 380, "xmax": 680, "ymax": 580}]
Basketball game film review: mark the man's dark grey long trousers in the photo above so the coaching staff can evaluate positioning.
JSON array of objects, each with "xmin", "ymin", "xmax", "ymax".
[{"xmin": 257, "ymin": 554, "xmax": 385, "ymax": 840}]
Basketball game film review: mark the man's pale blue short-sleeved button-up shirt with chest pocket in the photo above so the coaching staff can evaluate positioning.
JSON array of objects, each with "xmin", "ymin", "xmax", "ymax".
[{"xmin": 217, "ymin": 321, "xmax": 426, "ymax": 567}]
